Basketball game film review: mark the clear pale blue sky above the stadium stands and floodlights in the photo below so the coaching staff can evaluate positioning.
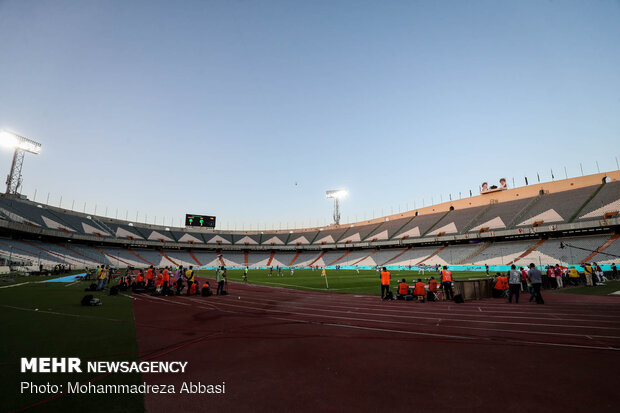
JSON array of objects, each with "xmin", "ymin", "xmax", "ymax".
[{"xmin": 0, "ymin": 0, "xmax": 620, "ymax": 229}]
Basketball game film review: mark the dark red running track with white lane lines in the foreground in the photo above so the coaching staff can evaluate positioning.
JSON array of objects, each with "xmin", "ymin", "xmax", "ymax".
[{"xmin": 134, "ymin": 283, "xmax": 620, "ymax": 413}]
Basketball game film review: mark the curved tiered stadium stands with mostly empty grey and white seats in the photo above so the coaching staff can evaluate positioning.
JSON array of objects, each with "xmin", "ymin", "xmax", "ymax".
[{"xmin": 0, "ymin": 171, "xmax": 620, "ymax": 271}]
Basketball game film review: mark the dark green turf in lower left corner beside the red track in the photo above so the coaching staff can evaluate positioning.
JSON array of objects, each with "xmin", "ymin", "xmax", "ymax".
[{"xmin": 0, "ymin": 277, "xmax": 144, "ymax": 412}]
